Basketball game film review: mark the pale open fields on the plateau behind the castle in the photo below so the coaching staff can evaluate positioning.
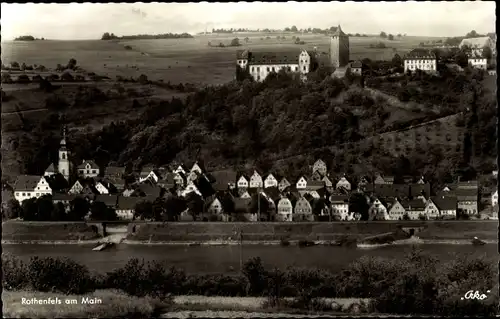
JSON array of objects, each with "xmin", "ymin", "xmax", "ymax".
[{"xmin": 2, "ymin": 33, "xmax": 438, "ymax": 84}]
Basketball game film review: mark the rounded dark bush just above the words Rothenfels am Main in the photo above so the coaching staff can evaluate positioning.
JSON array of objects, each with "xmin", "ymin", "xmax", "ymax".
[{"xmin": 26, "ymin": 257, "xmax": 95, "ymax": 294}]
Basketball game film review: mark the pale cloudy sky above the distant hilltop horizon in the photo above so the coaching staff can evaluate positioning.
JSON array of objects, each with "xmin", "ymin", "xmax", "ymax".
[{"xmin": 0, "ymin": 1, "xmax": 496, "ymax": 40}]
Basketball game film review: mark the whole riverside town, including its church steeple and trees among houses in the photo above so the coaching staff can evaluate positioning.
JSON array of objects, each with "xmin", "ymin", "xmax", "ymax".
[{"xmin": 4, "ymin": 125, "xmax": 498, "ymax": 222}]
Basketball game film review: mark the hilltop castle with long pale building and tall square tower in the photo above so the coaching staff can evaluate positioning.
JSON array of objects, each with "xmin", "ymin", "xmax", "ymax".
[{"xmin": 236, "ymin": 26, "xmax": 349, "ymax": 81}]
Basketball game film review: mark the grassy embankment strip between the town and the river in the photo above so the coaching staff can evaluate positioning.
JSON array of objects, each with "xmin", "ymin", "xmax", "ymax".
[{"xmin": 2, "ymin": 221, "xmax": 498, "ymax": 246}]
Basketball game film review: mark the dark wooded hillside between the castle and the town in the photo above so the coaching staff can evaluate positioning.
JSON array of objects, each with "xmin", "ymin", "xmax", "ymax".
[{"xmin": 2, "ymin": 66, "xmax": 496, "ymax": 191}]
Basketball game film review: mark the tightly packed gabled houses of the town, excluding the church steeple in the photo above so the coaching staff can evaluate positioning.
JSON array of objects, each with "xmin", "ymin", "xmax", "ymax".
[{"xmin": 10, "ymin": 160, "xmax": 498, "ymax": 221}]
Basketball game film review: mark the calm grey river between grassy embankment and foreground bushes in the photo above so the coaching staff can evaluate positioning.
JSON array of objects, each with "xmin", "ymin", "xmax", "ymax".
[{"xmin": 2, "ymin": 244, "xmax": 499, "ymax": 273}]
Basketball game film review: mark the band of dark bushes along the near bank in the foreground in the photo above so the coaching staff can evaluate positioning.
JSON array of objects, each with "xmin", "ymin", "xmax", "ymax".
[{"xmin": 2, "ymin": 251, "xmax": 499, "ymax": 315}]
